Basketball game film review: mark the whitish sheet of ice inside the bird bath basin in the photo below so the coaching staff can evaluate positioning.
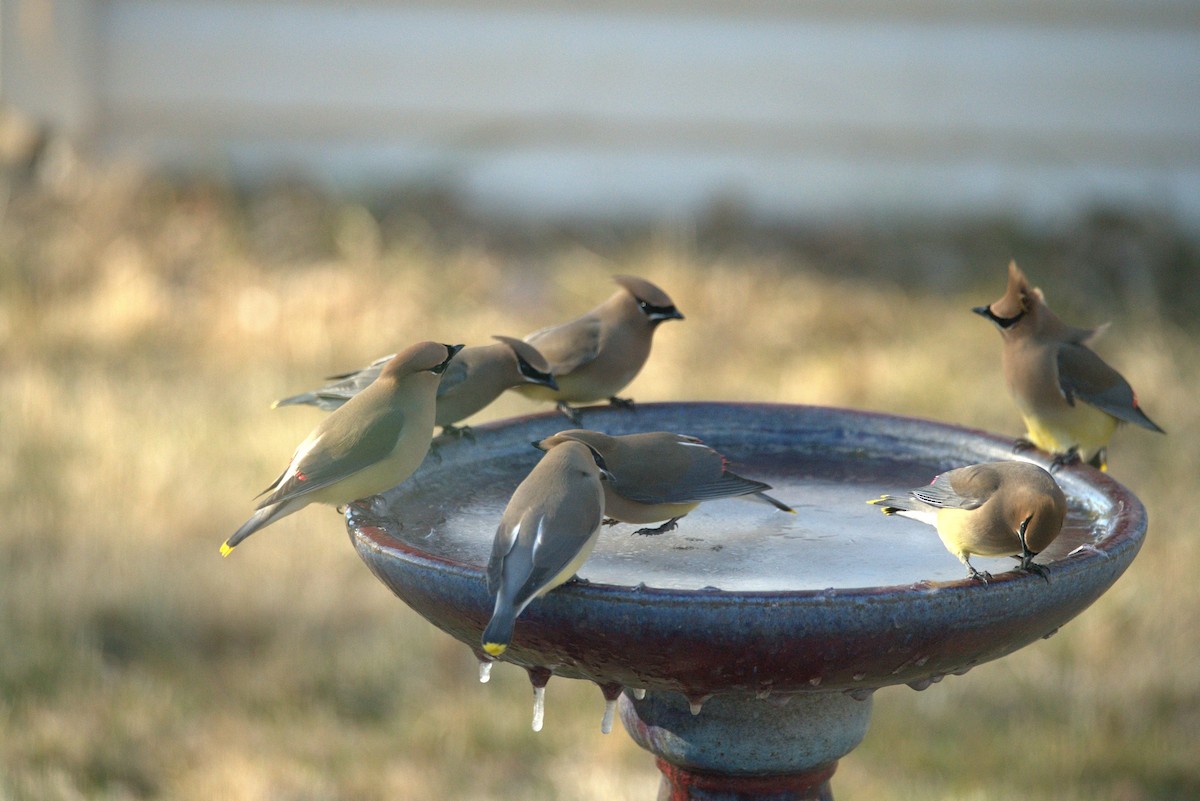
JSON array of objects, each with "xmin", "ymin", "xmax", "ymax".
[{"xmin": 372, "ymin": 454, "xmax": 1104, "ymax": 592}]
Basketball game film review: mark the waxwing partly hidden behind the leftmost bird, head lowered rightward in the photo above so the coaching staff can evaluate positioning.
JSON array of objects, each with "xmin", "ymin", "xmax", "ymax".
[{"xmin": 271, "ymin": 335, "xmax": 558, "ymax": 435}]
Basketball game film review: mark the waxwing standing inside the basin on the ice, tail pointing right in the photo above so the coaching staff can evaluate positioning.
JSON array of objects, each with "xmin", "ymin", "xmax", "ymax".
[{"xmin": 533, "ymin": 428, "xmax": 796, "ymax": 535}]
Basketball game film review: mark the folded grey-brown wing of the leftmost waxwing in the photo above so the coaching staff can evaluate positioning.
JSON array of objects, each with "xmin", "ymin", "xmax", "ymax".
[{"xmin": 259, "ymin": 405, "xmax": 404, "ymax": 508}]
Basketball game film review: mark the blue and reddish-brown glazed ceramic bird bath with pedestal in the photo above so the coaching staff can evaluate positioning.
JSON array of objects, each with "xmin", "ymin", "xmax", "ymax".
[{"xmin": 347, "ymin": 403, "xmax": 1146, "ymax": 801}]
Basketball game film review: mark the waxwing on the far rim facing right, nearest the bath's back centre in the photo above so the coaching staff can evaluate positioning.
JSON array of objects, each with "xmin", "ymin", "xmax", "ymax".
[{"xmin": 516, "ymin": 276, "xmax": 684, "ymax": 426}]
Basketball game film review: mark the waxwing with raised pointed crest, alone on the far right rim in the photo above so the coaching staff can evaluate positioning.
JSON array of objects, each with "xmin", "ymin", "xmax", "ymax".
[{"xmin": 971, "ymin": 261, "xmax": 1164, "ymax": 470}]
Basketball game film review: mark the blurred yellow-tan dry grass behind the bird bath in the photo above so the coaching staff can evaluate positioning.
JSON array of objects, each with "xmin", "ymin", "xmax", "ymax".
[{"xmin": 0, "ymin": 167, "xmax": 1200, "ymax": 801}]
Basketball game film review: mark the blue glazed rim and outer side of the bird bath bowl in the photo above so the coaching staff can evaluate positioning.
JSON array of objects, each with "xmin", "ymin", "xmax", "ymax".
[{"xmin": 347, "ymin": 403, "xmax": 1146, "ymax": 697}]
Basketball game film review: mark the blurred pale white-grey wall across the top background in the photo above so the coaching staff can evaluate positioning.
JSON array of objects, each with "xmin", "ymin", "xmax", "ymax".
[{"xmin": 0, "ymin": 0, "xmax": 1200, "ymax": 224}]
